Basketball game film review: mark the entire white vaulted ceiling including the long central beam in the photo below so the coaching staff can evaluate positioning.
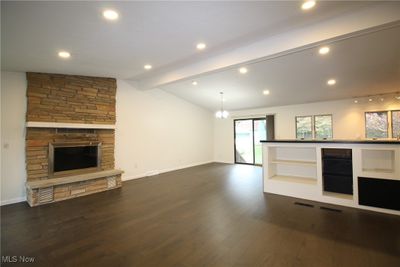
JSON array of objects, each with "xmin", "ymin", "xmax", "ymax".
[{"xmin": 1, "ymin": 1, "xmax": 400, "ymax": 110}]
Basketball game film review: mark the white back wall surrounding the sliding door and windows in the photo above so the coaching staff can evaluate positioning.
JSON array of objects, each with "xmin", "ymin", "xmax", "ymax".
[{"xmin": 214, "ymin": 97, "xmax": 400, "ymax": 163}]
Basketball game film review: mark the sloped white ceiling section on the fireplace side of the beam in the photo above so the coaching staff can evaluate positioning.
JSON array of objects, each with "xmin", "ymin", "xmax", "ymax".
[{"xmin": 1, "ymin": 1, "xmax": 376, "ymax": 80}]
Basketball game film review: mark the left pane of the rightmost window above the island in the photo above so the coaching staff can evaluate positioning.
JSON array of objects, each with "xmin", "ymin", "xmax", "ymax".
[{"xmin": 365, "ymin": 111, "xmax": 388, "ymax": 138}]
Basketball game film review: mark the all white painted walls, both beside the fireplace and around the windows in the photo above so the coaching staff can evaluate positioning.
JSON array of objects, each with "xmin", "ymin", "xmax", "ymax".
[{"xmin": 1, "ymin": 72, "xmax": 400, "ymax": 204}]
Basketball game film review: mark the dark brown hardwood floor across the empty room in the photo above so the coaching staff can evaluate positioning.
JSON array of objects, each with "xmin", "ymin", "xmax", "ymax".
[{"xmin": 1, "ymin": 164, "xmax": 400, "ymax": 267}]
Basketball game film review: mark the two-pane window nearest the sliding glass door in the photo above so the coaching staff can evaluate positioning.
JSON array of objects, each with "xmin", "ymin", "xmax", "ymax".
[{"xmin": 296, "ymin": 115, "xmax": 333, "ymax": 139}]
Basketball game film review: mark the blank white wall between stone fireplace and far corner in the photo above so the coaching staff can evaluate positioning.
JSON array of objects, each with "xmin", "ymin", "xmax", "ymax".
[{"xmin": 116, "ymin": 80, "xmax": 214, "ymax": 179}]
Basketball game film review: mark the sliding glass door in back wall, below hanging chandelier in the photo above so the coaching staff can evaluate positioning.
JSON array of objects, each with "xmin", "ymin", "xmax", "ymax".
[{"xmin": 234, "ymin": 118, "xmax": 267, "ymax": 165}]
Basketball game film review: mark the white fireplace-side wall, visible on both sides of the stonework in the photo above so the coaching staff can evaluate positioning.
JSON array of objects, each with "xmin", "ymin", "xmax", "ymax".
[{"xmin": 1, "ymin": 72, "xmax": 213, "ymax": 205}]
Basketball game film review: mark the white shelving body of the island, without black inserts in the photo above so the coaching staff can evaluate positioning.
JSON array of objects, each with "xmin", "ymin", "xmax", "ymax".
[{"xmin": 263, "ymin": 141, "xmax": 400, "ymax": 215}]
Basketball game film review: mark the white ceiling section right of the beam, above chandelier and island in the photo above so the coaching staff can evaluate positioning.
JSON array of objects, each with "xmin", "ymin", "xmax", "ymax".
[{"xmin": 161, "ymin": 26, "xmax": 400, "ymax": 111}]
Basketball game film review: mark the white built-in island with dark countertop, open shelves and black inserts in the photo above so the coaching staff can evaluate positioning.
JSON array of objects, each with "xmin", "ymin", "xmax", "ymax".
[{"xmin": 261, "ymin": 140, "xmax": 400, "ymax": 215}]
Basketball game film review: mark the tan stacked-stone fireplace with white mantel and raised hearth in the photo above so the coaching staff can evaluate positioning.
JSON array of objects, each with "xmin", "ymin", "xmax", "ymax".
[{"xmin": 26, "ymin": 73, "xmax": 122, "ymax": 206}]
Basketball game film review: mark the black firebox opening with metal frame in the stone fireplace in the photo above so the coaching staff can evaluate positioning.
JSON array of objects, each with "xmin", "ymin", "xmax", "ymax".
[{"xmin": 49, "ymin": 142, "xmax": 101, "ymax": 176}]
